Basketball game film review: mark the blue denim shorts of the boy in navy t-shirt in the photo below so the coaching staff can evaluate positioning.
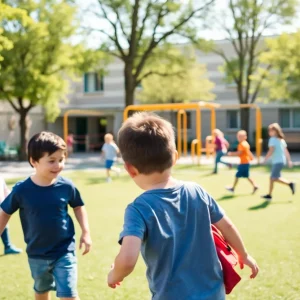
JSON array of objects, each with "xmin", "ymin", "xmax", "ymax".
[{"xmin": 28, "ymin": 252, "xmax": 77, "ymax": 298}]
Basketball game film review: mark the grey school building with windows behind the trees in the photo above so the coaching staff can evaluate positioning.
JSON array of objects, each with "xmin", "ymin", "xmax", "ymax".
[{"xmin": 0, "ymin": 40, "xmax": 300, "ymax": 151}]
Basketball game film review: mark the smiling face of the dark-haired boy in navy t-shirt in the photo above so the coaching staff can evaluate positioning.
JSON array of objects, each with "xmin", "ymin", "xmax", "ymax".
[{"xmin": 31, "ymin": 150, "xmax": 66, "ymax": 180}]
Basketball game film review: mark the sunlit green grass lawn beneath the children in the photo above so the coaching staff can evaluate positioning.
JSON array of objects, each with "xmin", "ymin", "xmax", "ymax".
[{"xmin": 0, "ymin": 166, "xmax": 300, "ymax": 300}]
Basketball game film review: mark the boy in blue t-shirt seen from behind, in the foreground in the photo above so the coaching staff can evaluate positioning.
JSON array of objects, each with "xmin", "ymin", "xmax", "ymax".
[{"xmin": 107, "ymin": 113, "xmax": 258, "ymax": 300}]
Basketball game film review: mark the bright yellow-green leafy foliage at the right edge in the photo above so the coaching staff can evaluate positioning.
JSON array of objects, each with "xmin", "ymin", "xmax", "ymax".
[{"xmin": 252, "ymin": 31, "xmax": 300, "ymax": 102}]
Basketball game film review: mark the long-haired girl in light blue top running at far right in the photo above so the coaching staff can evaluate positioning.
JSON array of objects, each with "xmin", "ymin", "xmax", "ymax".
[{"xmin": 262, "ymin": 123, "xmax": 295, "ymax": 200}]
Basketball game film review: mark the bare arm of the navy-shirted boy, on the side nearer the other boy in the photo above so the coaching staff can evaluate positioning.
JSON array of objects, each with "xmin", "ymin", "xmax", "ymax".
[{"xmin": 74, "ymin": 206, "xmax": 92, "ymax": 255}]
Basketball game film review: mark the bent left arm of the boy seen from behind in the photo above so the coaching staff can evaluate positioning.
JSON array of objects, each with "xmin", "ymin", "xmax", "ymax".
[{"xmin": 107, "ymin": 236, "xmax": 142, "ymax": 289}]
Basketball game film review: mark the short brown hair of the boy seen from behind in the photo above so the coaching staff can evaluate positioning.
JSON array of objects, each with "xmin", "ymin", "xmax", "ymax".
[{"xmin": 118, "ymin": 112, "xmax": 176, "ymax": 174}]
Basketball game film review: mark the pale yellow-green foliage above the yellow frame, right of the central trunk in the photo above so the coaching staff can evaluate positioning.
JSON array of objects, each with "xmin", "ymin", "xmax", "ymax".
[{"xmin": 137, "ymin": 48, "xmax": 215, "ymax": 103}]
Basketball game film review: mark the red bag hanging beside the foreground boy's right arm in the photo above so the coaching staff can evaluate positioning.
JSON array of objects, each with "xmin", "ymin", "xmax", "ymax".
[{"xmin": 211, "ymin": 225, "xmax": 241, "ymax": 294}]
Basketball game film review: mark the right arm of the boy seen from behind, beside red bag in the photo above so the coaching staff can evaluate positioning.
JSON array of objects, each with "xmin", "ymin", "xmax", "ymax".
[{"xmin": 214, "ymin": 216, "xmax": 259, "ymax": 278}]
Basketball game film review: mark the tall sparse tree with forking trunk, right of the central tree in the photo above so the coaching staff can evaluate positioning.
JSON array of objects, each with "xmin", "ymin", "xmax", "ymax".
[{"xmin": 210, "ymin": 0, "xmax": 297, "ymax": 131}]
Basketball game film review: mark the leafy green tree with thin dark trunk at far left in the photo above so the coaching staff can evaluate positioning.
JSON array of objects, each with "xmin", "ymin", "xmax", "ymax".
[{"xmin": 0, "ymin": 0, "xmax": 108, "ymax": 160}]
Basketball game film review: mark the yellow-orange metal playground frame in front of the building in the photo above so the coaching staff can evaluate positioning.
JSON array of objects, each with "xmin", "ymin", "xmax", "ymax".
[{"xmin": 63, "ymin": 102, "xmax": 262, "ymax": 164}]
